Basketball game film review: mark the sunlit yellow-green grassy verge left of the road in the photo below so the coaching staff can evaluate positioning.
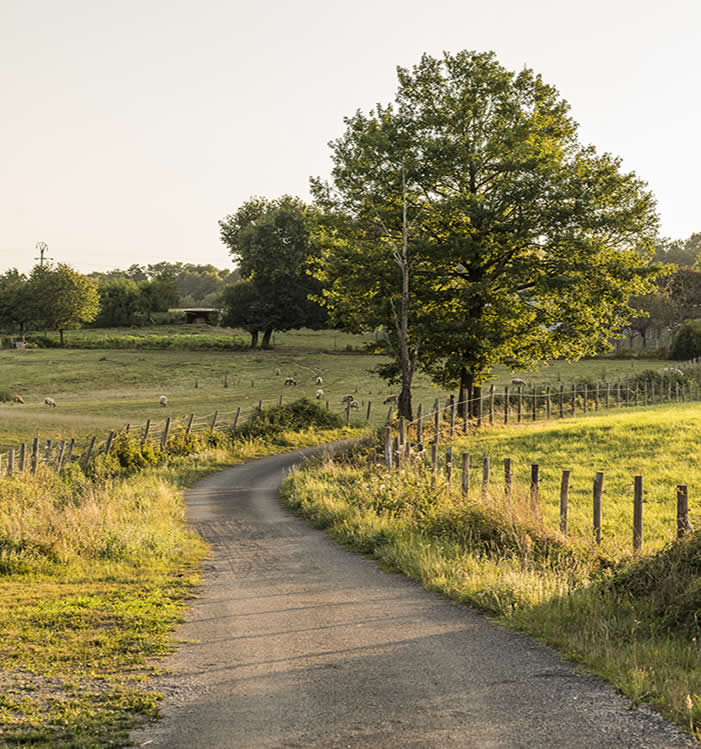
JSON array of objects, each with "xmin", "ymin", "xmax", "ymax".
[{"xmin": 0, "ymin": 400, "xmax": 366, "ymax": 749}]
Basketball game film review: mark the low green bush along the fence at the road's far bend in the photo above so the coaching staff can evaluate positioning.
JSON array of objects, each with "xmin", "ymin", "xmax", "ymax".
[{"xmin": 236, "ymin": 398, "xmax": 344, "ymax": 444}]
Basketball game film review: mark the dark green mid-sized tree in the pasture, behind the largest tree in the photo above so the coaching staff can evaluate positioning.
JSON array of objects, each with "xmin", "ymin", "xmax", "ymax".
[{"xmin": 219, "ymin": 195, "xmax": 326, "ymax": 347}]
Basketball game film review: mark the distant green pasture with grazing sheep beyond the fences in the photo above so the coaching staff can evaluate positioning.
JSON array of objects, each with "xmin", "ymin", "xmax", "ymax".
[{"xmin": 0, "ymin": 326, "xmax": 668, "ymax": 451}]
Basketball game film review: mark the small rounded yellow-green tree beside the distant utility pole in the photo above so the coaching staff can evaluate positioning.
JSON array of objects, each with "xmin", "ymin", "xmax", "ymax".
[{"xmin": 29, "ymin": 263, "xmax": 100, "ymax": 345}]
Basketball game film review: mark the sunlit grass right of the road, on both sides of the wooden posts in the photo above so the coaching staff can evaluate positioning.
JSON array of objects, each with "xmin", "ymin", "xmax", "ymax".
[{"xmin": 283, "ymin": 405, "xmax": 701, "ymax": 740}]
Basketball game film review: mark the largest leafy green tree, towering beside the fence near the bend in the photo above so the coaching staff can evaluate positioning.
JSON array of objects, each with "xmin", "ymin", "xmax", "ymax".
[{"xmin": 312, "ymin": 52, "xmax": 658, "ymax": 416}]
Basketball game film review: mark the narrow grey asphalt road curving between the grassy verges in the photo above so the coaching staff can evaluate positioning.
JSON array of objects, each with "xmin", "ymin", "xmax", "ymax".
[{"xmin": 132, "ymin": 444, "xmax": 697, "ymax": 749}]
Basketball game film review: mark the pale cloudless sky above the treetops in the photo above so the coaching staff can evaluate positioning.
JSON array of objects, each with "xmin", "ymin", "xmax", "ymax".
[{"xmin": 0, "ymin": 0, "xmax": 701, "ymax": 273}]
